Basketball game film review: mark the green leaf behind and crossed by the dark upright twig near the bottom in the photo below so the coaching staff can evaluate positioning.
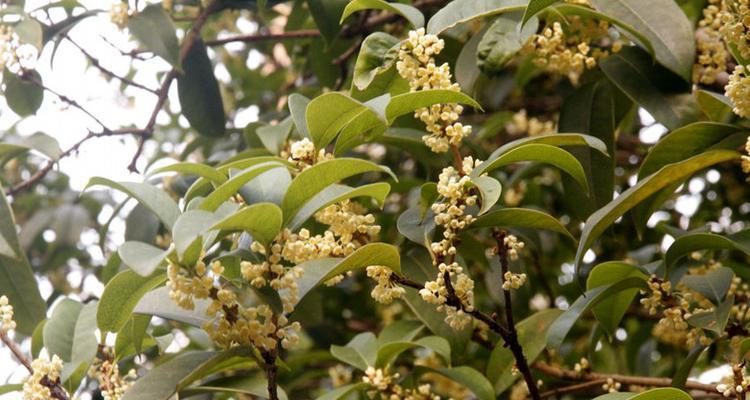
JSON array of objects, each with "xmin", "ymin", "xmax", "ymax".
[{"xmin": 487, "ymin": 309, "xmax": 562, "ymax": 394}]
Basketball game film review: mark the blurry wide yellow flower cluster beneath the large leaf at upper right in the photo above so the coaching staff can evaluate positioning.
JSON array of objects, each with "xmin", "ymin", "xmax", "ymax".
[{"xmin": 525, "ymin": 12, "xmax": 622, "ymax": 83}]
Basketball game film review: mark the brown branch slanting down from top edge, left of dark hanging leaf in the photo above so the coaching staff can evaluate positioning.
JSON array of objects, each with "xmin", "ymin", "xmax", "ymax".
[{"xmin": 128, "ymin": 0, "xmax": 219, "ymax": 172}]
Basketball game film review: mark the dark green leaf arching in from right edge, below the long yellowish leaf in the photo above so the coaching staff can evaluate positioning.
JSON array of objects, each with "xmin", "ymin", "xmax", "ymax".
[{"xmin": 664, "ymin": 230, "xmax": 750, "ymax": 269}]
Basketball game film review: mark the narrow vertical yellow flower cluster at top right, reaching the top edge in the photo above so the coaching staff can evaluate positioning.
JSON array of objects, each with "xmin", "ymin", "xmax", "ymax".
[{"xmin": 693, "ymin": 0, "xmax": 729, "ymax": 85}]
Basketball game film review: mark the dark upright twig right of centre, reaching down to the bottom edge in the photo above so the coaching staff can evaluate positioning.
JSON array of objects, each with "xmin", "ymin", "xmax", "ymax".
[{"xmin": 492, "ymin": 229, "xmax": 541, "ymax": 400}]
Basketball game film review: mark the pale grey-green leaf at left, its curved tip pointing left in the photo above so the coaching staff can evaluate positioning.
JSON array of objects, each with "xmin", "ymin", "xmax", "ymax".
[{"xmin": 84, "ymin": 177, "xmax": 180, "ymax": 229}]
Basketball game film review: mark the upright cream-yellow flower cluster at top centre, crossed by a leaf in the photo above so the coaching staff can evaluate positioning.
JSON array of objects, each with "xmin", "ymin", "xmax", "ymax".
[{"xmin": 396, "ymin": 28, "xmax": 471, "ymax": 153}]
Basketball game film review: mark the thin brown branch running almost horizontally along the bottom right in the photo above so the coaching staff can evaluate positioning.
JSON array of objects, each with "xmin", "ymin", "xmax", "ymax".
[{"xmin": 533, "ymin": 362, "xmax": 716, "ymax": 393}]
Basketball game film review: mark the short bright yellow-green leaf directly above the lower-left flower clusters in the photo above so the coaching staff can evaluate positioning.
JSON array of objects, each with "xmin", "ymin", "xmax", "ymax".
[{"xmin": 211, "ymin": 203, "xmax": 282, "ymax": 244}]
